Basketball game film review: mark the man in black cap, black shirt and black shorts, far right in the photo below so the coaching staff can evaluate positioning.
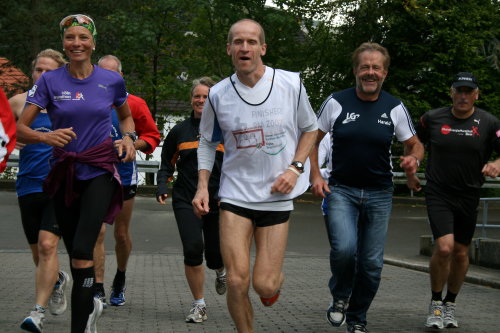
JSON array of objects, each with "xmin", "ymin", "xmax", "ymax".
[{"xmin": 412, "ymin": 72, "xmax": 500, "ymax": 328}]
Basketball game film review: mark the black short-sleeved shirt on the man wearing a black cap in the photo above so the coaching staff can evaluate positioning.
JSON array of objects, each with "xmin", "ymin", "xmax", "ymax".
[{"xmin": 417, "ymin": 107, "xmax": 500, "ymax": 192}]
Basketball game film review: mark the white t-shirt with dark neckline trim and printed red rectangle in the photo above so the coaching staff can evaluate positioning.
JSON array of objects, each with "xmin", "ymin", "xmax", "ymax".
[{"xmin": 198, "ymin": 67, "xmax": 317, "ymax": 210}]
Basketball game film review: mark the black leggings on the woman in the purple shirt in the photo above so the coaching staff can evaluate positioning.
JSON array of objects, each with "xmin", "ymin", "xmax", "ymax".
[{"xmin": 54, "ymin": 173, "xmax": 116, "ymax": 260}]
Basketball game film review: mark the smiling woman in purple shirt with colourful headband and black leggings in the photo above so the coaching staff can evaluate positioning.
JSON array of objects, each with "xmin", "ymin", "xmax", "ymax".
[{"xmin": 18, "ymin": 14, "xmax": 135, "ymax": 333}]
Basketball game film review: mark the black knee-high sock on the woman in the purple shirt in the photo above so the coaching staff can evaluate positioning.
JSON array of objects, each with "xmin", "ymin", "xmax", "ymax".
[{"xmin": 71, "ymin": 267, "xmax": 95, "ymax": 332}]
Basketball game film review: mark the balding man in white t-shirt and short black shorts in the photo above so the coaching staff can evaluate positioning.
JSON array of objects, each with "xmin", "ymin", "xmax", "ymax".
[{"xmin": 193, "ymin": 19, "xmax": 317, "ymax": 332}]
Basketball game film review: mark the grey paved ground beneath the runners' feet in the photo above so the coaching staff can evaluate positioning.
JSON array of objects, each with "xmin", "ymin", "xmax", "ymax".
[{"xmin": 0, "ymin": 191, "xmax": 500, "ymax": 333}]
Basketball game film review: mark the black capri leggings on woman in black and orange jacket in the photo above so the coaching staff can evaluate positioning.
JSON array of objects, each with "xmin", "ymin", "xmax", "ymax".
[{"xmin": 173, "ymin": 205, "xmax": 223, "ymax": 269}]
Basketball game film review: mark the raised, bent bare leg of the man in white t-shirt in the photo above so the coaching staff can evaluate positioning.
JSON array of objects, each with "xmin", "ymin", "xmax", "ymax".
[{"xmin": 253, "ymin": 221, "xmax": 289, "ymax": 298}]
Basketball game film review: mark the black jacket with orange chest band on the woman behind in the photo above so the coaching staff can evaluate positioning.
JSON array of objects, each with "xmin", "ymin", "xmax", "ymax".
[{"xmin": 156, "ymin": 112, "xmax": 224, "ymax": 207}]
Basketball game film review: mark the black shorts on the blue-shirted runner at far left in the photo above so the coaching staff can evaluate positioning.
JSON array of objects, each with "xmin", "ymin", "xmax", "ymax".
[{"xmin": 17, "ymin": 192, "xmax": 61, "ymax": 244}]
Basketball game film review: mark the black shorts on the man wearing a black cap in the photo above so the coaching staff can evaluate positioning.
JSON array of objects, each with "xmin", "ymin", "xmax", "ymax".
[{"xmin": 425, "ymin": 186, "xmax": 479, "ymax": 245}]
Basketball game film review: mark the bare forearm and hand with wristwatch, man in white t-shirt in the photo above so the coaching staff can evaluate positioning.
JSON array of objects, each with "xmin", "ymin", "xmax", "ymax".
[{"xmin": 271, "ymin": 130, "xmax": 318, "ymax": 194}]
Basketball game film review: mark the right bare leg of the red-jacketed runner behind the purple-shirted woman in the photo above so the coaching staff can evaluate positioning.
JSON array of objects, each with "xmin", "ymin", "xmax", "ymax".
[{"xmin": 114, "ymin": 198, "xmax": 135, "ymax": 272}]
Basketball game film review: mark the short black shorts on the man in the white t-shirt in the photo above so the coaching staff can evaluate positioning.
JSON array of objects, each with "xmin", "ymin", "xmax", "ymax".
[{"xmin": 220, "ymin": 202, "xmax": 292, "ymax": 227}]
